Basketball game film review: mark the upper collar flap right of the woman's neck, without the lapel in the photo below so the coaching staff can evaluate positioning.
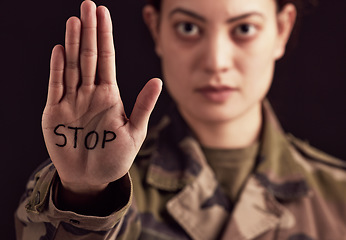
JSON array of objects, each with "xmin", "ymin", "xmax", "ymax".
[{"xmin": 255, "ymin": 101, "xmax": 309, "ymax": 201}]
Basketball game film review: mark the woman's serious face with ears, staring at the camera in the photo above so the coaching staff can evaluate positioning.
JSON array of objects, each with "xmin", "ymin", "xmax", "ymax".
[{"xmin": 146, "ymin": 0, "xmax": 293, "ymax": 123}]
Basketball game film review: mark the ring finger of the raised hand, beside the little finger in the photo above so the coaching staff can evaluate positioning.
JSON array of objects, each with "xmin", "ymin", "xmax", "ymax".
[{"xmin": 65, "ymin": 17, "xmax": 81, "ymax": 97}]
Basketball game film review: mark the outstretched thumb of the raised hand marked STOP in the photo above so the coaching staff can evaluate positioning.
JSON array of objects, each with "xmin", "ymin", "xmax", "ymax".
[{"xmin": 130, "ymin": 78, "xmax": 162, "ymax": 130}]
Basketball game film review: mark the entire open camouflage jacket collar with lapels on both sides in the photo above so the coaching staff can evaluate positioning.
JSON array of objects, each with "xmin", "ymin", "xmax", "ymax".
[{"xmin": 141, "ymin": 101, "xmax": 308, "ymax": 239}]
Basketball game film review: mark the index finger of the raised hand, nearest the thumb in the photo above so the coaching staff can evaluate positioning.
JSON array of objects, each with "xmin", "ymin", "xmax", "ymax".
[{"xmin": 96, "ymin": 6, "xmax": 116, "ymax": 84}]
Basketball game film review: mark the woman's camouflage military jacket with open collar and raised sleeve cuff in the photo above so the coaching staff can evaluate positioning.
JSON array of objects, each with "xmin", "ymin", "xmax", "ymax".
[{"xmin": 15, "ymin": 103, "xmax": 346, "ymax": 240}]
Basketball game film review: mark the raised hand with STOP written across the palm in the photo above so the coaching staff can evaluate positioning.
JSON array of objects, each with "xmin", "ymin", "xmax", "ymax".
[{"xmin": 42, "ymin": 0, "xmax": 162, "ymax": 197}]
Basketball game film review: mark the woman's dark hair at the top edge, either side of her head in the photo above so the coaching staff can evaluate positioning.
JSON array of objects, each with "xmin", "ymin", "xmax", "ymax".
[{"xmin": 146, "ymin": 0, "xmax": 318, "ymax": 13}]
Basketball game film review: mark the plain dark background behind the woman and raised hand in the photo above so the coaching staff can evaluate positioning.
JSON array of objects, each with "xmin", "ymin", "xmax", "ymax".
[{"xmin": 0, "ymin": 0, "xmax": 346, "ymax": 240}]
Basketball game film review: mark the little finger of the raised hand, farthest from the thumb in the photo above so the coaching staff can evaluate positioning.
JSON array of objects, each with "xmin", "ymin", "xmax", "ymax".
[{"xmin": 47, "ymin": 45, "xmax": 65, "ymax": 105}]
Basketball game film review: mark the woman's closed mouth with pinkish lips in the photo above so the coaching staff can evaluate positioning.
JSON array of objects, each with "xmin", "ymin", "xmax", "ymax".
[{"xmin": 196, "ymin": 86, "xmax": 238, "ymax": 103}]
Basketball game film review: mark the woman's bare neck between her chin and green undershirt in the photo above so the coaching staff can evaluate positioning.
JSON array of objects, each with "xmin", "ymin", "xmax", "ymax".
[{"xmin": 184, "ymin": 104, "xmax": 262, "ymax": 149}]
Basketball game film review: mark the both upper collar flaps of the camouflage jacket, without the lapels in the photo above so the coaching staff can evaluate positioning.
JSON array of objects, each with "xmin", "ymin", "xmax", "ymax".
[{"xmin": 147, "ymin": 100, "xmax": 308, "ymax": 201}]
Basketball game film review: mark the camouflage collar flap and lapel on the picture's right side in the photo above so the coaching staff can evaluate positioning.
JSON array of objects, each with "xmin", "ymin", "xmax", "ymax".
[{"xmin": 222, "ymin": 101, "xmax": 309, "ymax": 240}]
